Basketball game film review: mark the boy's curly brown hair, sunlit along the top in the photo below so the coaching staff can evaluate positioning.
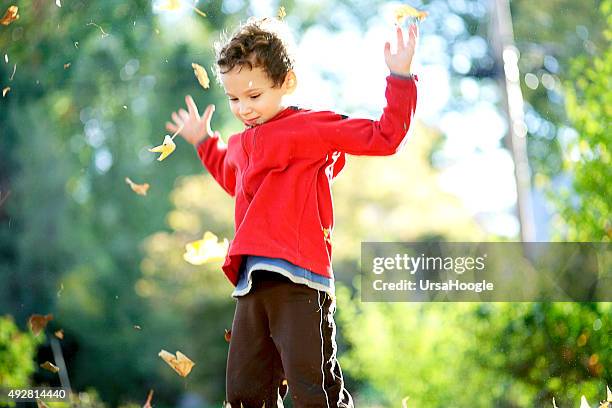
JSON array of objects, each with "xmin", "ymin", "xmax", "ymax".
[{"xmin": 215, "ymin": 18, "xmax": 295, "ymax": 87}]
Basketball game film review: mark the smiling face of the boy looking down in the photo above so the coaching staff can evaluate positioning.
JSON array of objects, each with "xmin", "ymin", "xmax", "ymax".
[{"xmin": 221, "ymin": 66, "xmax": 294, "ymax": 126}]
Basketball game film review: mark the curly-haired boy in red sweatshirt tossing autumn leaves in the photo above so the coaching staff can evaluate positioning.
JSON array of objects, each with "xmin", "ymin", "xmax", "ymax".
[{"xmin": 166, "ymin": 19, "xmax": 418, "ymax": 408}]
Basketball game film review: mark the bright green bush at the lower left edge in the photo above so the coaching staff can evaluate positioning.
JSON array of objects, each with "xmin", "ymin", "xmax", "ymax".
[{"xmin": 0, "ymin": 315, "xmax": 44, "ymax": 387}]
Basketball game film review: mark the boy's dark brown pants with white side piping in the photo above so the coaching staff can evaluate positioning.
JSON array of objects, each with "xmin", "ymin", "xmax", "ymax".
[{"xmin": 226, "ymin": 271, "xmax": 353, "ymax": 408}]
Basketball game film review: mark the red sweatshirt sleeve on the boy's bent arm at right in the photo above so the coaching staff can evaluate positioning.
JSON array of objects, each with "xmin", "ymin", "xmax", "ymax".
[{"xmin": 317, "ymin": 75, "xmax": 417, "ymax": 156}]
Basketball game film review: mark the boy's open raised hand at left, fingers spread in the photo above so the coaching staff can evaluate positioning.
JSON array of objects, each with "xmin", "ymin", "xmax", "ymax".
[{"xmin": 166, "ymin": 95, "xmax": 215, "ymax": 146}]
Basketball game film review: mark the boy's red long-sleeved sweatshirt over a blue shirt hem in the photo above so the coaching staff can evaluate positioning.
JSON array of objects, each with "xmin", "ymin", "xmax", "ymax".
[{"xmin": 197, "ymin": 76, "xmax": 417, "ymax": 286}]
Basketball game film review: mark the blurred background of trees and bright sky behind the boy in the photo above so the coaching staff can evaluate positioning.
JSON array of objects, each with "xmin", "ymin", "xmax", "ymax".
[{"xmin": 0, "ymin": 0, "xmax": 612, "ymax": 408}]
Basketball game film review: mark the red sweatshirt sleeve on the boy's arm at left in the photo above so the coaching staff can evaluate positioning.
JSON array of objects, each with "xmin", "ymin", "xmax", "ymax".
[{"xmin": 196, "ymin": 136, "xmax": 236, "ymax": 197}]
